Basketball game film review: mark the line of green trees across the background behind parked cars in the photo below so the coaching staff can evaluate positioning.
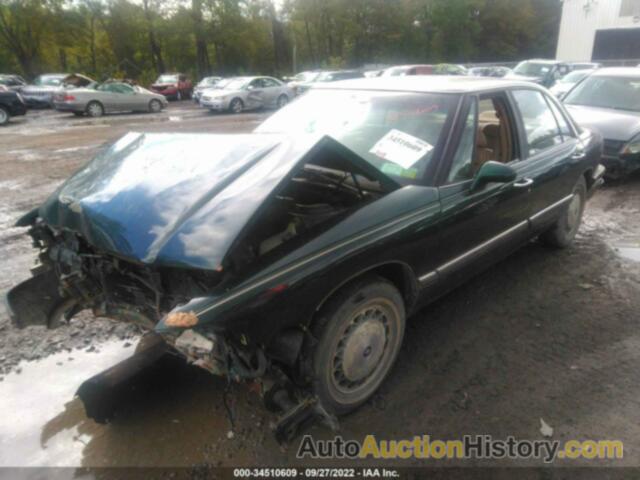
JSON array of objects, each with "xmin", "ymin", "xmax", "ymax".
[{"xmin": 0, "ymin": 0, "xmax": 561, "ymax": 82}]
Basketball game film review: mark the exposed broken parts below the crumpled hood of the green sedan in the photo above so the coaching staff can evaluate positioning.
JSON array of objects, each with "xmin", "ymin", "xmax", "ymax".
[{"xmin": 7, "ymin": 220, "xmax": 221, "ymax": 330}]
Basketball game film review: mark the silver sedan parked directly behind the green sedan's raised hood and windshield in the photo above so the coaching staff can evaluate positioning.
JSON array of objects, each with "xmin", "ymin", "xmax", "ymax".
[{"xmin": 200, "ymin": 77, "xmax": 294, "ymax": 113}]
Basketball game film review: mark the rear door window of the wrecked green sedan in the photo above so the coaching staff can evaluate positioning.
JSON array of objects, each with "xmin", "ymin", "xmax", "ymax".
[{"xmin": 513, "ymin": 90, "xmax": 562, "ymax": 156}]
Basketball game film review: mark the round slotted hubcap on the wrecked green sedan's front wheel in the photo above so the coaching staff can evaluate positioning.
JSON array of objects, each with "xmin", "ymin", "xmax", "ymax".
[{"xmin": 333, "ymin": 306, "xmax": 389, "ymax": 393}]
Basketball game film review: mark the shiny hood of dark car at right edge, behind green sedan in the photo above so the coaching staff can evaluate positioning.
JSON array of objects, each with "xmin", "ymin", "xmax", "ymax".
[{"xmin": 565, "ymin": 105, "xmax": 640, "ymax": 142}]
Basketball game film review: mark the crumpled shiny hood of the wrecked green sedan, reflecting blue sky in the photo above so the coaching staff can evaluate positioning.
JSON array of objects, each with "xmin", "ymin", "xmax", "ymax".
[{"xmin": 39, "ymin": 133, "xmax": 317, "ymax": 269}]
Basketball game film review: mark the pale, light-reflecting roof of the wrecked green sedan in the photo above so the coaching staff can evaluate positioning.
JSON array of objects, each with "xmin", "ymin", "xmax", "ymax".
[{"xmin": 314, "ymin": 75, "xmax": 542, "ymax": 93}]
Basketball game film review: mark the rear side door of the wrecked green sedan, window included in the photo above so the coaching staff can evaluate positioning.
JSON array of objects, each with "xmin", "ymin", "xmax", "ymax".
[{"xmin": 511, "ymin": 89, "xmax": 584, "ymax": 232}]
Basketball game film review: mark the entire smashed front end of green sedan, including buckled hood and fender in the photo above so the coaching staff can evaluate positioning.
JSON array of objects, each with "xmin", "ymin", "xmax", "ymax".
[{"xmin": 7, "ymin": 129, "xmax": 400, "ymax": 440}]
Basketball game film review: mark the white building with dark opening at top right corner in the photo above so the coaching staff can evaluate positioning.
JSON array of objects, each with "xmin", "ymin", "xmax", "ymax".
[{"xmin": 556, "ymin": 0, "xmax": 640, "ymax": 61}]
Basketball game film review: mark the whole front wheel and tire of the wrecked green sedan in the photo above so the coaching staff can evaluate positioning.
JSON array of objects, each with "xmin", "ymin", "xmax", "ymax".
[{"xmin": 309, "ymin": 276, "xmax": 405, "ymax": 415}]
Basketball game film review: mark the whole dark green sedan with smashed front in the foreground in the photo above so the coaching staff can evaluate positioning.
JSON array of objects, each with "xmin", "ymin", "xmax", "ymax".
[{"xmin": 8, "ymin": 77, "xmax": 603, "ymax": 438}]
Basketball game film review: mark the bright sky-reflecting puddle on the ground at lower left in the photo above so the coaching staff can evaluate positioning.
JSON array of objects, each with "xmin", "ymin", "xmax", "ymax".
[{"xmin": 0, "ymin": 341, "xmax": 133, "ymax": 467}]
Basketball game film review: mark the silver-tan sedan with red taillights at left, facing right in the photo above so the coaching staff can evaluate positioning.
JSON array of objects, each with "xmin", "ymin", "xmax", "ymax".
[{"xmin": 53, "ymin": 82, "xmax": 169, "ymax": 117}]
